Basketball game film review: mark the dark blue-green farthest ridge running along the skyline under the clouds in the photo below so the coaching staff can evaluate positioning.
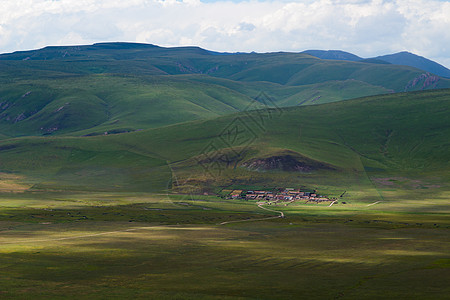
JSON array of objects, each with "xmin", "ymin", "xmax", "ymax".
[{"xmin": 0, "ymin": 43, "xmax": 450, "ymax": 92}]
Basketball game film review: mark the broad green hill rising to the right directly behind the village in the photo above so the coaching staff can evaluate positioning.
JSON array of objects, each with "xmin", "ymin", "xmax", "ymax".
[{"xmin": 0, "ymin": 90, "xmax": 450, "ymax": 200}]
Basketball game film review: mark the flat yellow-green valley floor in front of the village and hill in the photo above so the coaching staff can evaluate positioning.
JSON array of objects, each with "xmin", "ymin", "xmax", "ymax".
[{"xmin": 0, "ymin": 193, "xmax": 450, "ymax": 299}]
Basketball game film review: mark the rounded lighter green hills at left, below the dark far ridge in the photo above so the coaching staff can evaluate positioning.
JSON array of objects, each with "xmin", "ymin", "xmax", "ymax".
[{"xmin": 0, "ymin": 75, "xmax": 258, "ymax": 136}]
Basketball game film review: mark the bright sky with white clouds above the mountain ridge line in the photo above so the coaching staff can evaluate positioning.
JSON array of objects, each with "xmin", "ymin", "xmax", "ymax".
[{"xmin": 0, "ymin": 0, "xmax": 450, "ymax": 68}]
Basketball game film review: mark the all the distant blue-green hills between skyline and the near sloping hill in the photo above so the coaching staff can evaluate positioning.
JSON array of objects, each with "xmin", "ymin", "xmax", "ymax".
[{"xmin": 0, "ymin": 43, "xmax": 450, "ymax": 136}]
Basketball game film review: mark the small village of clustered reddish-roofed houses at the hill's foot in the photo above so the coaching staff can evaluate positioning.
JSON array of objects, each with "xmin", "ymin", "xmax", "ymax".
[{"xmin": 228, "ymin": 188, "xmax": 337, "ymax": 205}]
